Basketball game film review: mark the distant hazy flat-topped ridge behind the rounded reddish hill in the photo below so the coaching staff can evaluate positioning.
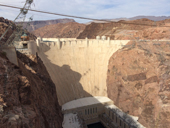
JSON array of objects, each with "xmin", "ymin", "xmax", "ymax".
[{"xmin": 16, "ymin": 19, "xmax": 75, "ymax": 32}]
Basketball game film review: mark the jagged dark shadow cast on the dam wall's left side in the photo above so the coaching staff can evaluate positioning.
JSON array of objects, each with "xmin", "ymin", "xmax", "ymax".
[{"xmin": 38, "ymin": 44, "xmax": 92, "ymax": 105}]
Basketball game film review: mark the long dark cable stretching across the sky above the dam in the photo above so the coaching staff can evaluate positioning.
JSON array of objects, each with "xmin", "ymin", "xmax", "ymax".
[{"xmin": 0, "ymin": 4, "xmax": 170, "ymax": 27}]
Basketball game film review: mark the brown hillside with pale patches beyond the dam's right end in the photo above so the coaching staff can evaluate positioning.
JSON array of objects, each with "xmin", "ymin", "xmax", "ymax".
[{"xmin": 77, "ymin": 19, "xmax": 170, "ymax": 40}]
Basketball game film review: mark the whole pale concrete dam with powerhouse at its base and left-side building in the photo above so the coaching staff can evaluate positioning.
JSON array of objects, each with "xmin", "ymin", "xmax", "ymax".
[{"xmin": 7, "ymin": 38, "xmax": 145, "ymax": 128}]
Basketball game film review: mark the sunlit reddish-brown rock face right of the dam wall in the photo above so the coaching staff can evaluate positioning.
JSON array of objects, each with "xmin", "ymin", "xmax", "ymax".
[{"xmin": 107, "ymin": 41, "xmax": 170, "ymax": 128}]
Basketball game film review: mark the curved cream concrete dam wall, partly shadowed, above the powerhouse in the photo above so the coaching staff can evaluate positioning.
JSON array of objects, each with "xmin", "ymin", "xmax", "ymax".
[{"xmin": 37, "ymin": 39, "xmax": 129, "ymax": 105}]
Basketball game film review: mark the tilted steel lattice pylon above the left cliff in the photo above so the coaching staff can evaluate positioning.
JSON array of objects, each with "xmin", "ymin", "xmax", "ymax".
[{"xmin": 0, "ymin": 0, "xmax": 33, "ymax": 46}]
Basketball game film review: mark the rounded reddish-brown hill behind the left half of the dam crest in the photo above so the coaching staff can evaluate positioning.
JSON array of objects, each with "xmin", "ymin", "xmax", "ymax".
[{"xmin": 33, "ymin": 22, "xmax": 85, "ymax": 38}]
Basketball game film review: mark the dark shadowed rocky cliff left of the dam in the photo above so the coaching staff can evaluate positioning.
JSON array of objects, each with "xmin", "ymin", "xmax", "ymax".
[{"xmin": 0, "ymin": 52, "xmax": 63, "ymax": 128}]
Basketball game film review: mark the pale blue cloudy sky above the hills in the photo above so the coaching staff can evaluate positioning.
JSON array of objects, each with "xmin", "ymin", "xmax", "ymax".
[{"xmin": 0, "ymin": 0, "xmax": 170, "ymax": 22}]
